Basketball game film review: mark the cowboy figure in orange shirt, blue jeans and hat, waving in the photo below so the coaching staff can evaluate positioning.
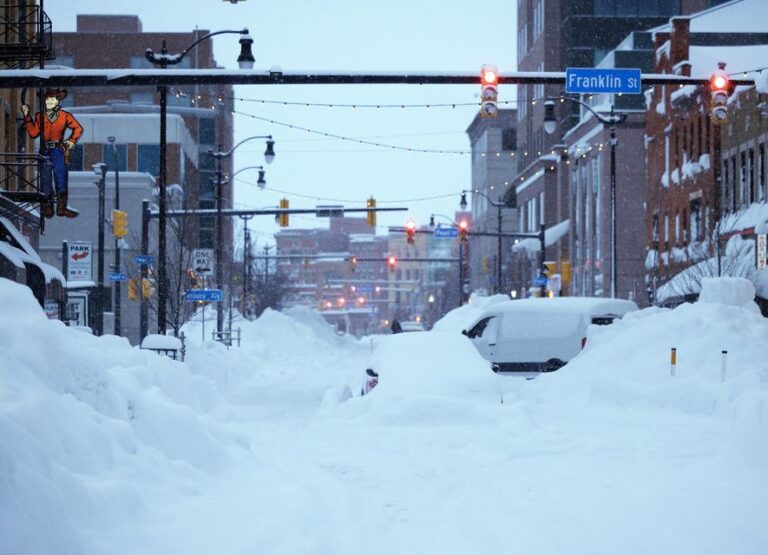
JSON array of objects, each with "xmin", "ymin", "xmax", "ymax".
[{"xmin": 21, "ymin": 89, "xmax": 83, "ymax": 218}]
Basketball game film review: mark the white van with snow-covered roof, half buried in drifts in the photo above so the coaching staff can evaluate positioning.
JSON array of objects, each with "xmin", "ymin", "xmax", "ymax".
[{"xmin": 462, "ymin": 297, "xmax": 637, "ymax": 372}]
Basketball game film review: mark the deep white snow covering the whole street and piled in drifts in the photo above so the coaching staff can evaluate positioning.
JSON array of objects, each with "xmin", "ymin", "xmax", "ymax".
[{"xmin": 0, "ymin": 279, "xmax": 768, "ymax": 555}]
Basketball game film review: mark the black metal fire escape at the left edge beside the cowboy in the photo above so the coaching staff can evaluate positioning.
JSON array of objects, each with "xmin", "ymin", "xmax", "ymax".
[{"xmin": 0, "ymin": 0, "xmax": 55, "ymax": 232}]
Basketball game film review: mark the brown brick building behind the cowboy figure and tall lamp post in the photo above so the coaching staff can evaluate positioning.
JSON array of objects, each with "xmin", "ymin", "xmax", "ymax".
[{"xmin": 54, "ymin": 15, "xmax": 239, "ymax": 252}]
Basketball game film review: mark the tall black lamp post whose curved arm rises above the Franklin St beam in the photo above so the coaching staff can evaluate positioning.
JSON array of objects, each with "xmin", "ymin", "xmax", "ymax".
[{"xmin": 144, "ymin": 29, "xmax": 255, "ymax": 334}]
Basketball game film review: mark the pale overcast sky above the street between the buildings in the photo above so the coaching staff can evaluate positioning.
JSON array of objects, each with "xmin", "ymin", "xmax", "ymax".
[{"xmin": 44, "ymin": 0, "xmax": 517, "ymax": 246}]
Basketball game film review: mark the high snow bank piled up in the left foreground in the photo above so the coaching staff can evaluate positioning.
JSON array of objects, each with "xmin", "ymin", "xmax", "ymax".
[{"xmin": 0, "ymin": 279, "xmax": 239, "ymax": 554}]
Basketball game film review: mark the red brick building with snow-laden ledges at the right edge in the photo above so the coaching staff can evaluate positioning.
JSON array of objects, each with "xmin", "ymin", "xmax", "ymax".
[{"xmin": 645, "ymin": 0, "xmax": 768, "ymax": 303}]
